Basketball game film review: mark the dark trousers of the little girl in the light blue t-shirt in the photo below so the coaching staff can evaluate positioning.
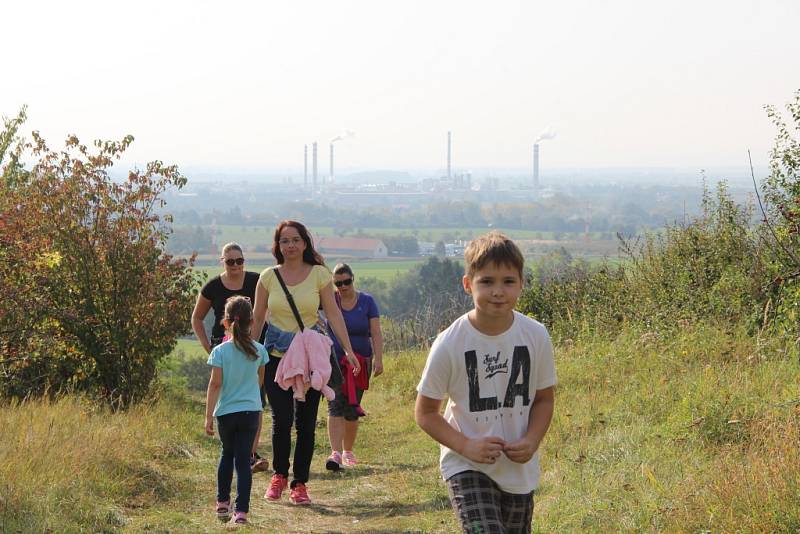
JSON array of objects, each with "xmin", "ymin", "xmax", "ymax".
[{"xmin": 217, "ymin": 412, "xmax": 258, "ymax": 513}]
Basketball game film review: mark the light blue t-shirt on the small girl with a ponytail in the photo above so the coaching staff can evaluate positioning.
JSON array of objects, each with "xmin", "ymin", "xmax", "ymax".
[{"xmin": 208, "ymin": 340, "xmax": 269, "ymax": 416}]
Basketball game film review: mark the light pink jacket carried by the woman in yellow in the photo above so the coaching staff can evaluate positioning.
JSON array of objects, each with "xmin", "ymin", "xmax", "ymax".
[{"xmin": 275, "ymin": 328, "xmax": 336, "ymax": 401}]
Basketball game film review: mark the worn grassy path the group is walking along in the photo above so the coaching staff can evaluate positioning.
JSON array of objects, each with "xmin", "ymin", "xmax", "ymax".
[{"xmin": 126, "ymin": 356, "xmax": 456, "ymax": 533}]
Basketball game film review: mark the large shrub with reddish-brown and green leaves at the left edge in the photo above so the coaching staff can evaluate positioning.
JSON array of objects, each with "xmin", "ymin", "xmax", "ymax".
[{"xmin": 0, "ymin": 113, "xmax": 197, "ymax": 407}]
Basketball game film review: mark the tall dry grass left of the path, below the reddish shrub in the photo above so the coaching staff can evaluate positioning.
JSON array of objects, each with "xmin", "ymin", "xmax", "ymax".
[{"xmin": 0, "ymin": 396, "xmax": 199, "ymax": 532}]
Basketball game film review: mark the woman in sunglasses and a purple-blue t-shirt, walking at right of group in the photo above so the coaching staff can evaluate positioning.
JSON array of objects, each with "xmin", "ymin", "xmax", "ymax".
[{"xmin": 325, "ymin": 263, "xmax": 383, "ymax": 471}]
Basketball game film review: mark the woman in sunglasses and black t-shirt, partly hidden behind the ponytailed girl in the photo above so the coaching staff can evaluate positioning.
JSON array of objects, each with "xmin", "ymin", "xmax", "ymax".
[{"xmin": 192, "ymin": 243, "xmax": 269, "ymax": 473}]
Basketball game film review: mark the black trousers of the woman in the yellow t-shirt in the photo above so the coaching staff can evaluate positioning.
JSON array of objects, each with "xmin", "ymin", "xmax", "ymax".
[{"xmin": 264, "ymin": 357, "xmax": 320, "ymax": 487}]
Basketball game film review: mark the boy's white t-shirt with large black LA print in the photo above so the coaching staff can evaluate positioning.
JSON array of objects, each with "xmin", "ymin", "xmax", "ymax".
[{"xmin": 417, "ymin": 311, "xmax": 556, "ymax": 494}]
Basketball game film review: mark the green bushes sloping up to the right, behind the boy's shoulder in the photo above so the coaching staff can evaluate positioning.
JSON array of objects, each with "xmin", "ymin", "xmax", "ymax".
[{"xmin": 519, "ymin": 183, "xmax": 768, "ymax": 337}]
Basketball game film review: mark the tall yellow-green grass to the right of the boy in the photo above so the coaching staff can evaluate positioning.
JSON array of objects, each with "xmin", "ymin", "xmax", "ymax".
[{"xmin": 535, "ymin": 324, "xmax": 800, "ymax": 533}]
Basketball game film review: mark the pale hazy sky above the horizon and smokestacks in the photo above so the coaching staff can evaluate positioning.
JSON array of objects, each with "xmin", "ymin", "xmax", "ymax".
[{"xmin": 0, "ymin": 0, "xmax": 800, "ymax": 174}]
